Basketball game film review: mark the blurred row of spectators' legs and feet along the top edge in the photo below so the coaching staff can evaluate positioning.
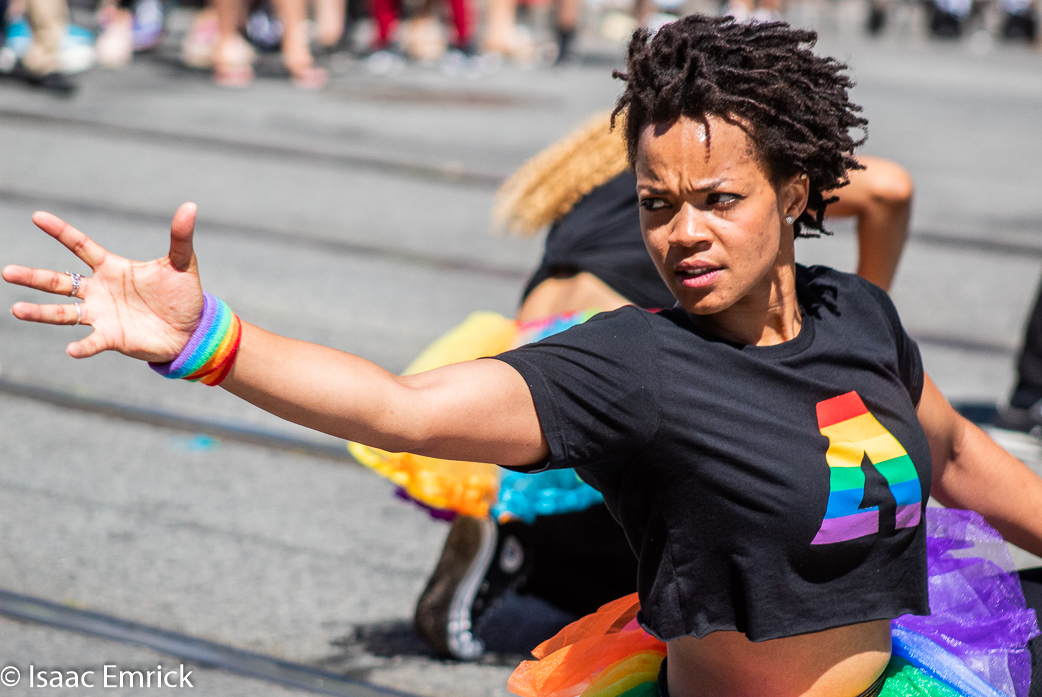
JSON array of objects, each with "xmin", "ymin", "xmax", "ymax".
[{"xmin": 0, "ymin": 0, "xmax": 1040, "ymax": 94}]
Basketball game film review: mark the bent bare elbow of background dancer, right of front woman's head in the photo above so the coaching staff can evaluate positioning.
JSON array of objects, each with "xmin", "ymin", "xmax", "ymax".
[{"xmin": 825, "ymin": 155, "xmax": 915, "ymax": 291}]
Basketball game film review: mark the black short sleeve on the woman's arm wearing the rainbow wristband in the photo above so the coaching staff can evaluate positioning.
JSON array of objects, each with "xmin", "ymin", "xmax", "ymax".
[{"xmin": 495, "ymin": 306, "xmax": 660, "ymax": 472}]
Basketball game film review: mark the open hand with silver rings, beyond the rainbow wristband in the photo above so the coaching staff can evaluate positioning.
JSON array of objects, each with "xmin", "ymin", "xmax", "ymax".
[{"xmin": 3, "ymin": 203, "xmax": 209, "ymax": 363}]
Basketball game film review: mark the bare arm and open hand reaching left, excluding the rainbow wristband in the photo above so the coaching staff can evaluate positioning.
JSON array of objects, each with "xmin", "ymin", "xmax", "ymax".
[{"xmin": 3, "ymin": 204, "xmax": 548, "ymax": 466}]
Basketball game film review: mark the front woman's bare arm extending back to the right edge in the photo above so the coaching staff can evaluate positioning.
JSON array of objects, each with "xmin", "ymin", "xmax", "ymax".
[{"xmin": 917, "ymin": 376, "xmax": 1042, "ymax": 556}]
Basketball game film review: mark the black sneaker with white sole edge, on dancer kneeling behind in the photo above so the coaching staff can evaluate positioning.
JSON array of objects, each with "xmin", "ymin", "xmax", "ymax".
[{"xmin": 415, "ymin": 516, "xmax": 531, "ymax": 661}]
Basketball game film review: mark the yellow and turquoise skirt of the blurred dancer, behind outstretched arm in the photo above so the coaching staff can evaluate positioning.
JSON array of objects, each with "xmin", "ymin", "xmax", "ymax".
[{"xmin": 347, "ymin": 310, "xmax": 603, "ymax": 523}]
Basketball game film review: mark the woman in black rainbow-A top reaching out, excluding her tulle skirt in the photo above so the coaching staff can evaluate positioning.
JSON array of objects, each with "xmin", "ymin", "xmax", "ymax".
[{"xmin": 3, "ymin": 16, "xmax": 1042, "ymax": 697}]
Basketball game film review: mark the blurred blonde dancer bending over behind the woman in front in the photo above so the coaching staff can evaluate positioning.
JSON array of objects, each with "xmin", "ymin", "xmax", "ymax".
[{"xmin": 349, "ymin": 108, "xmax": 913, "ymax": 659}]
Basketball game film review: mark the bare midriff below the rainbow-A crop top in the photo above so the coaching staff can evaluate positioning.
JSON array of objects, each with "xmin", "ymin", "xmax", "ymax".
[{"xmin": 667, "ymin": 620, "xmax": 890, "ymax": 697}]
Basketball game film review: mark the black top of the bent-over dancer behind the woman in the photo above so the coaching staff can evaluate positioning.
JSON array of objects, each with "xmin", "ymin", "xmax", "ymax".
[{"xmin": 522, "ymin": 171, "xmax": 676, "ymax": 309}]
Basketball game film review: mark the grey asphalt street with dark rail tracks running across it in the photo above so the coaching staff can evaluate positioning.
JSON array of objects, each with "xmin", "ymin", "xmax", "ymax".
[{"xmin": 0, "ymin": 3, "xmax": 1042, "ymax": 697}]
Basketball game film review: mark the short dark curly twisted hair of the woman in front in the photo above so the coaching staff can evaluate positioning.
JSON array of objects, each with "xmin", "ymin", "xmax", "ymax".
[{"xmin": 612, "ymin": 15, "xmax": 868, "ymax": 237}]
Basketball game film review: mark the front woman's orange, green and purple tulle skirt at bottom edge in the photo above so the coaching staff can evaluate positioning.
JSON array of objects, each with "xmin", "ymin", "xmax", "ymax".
[{"xmin": 510, "ymin": 508, "xmax": 1039, "ymax": 697}]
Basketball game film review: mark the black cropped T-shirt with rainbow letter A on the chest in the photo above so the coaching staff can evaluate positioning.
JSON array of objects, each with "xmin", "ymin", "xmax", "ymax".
[{"xmin": 497, "ymin": 267, "xmax": 931, "ymax": 641}]
